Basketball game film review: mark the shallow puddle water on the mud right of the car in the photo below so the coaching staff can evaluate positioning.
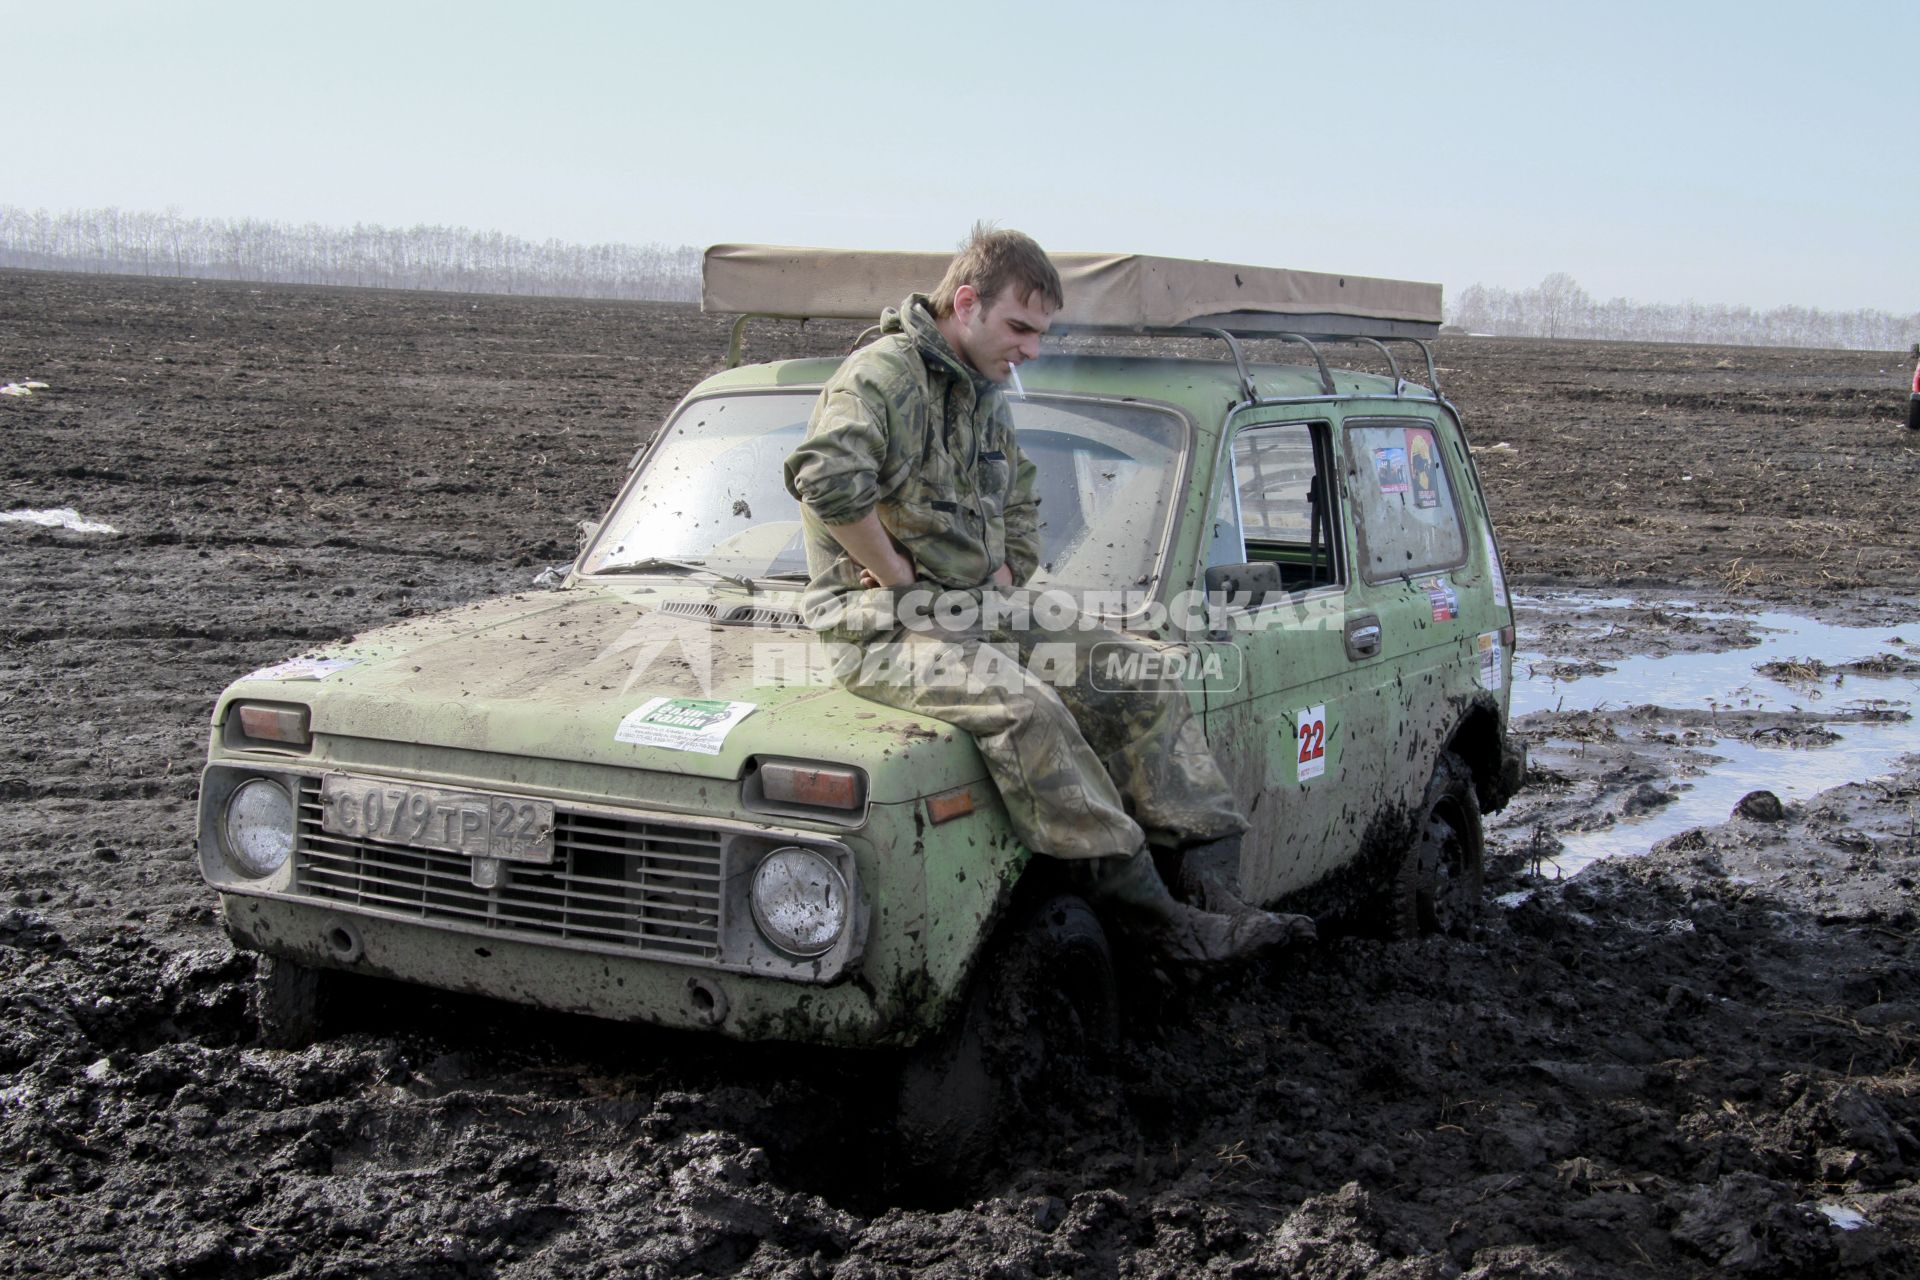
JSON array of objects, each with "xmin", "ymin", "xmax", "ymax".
[{"xmin": 1513, "ymin": 595, "xmax": 1920, "ymax": 875}]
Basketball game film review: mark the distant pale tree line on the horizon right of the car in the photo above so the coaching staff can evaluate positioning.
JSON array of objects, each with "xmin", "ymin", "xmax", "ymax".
[{"xmin": 1448, "ymin": 273, "xmax": 1920, "ymax": 351}]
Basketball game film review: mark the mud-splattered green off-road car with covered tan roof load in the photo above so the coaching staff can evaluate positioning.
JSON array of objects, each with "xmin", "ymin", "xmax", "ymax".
[{"xmin": 200, "ymin": 246, "xmax": 1523, "ymax": 1128}]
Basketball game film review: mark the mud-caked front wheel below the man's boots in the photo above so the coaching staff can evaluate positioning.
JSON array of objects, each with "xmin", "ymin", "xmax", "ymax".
[{"xmin": 897, "ymin": 894, "xmax": 1119, "ymax": 1182}]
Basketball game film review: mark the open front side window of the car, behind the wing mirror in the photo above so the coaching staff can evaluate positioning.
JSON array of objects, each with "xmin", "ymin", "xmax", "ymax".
[{"xmin": 1210, "ymin": 422, "xmax": 1340, "ymax": 591}]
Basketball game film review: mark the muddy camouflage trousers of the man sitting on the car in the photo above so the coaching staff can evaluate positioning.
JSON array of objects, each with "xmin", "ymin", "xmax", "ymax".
[{"xmin": 835, "ymin": 598, "xmax": 1246, "ymax": 858}]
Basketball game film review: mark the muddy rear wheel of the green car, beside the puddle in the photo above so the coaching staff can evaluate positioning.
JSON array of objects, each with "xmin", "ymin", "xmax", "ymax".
[{"xmin": 1380, "ymin": 750, "xmax": 1486, "ymax": 938}]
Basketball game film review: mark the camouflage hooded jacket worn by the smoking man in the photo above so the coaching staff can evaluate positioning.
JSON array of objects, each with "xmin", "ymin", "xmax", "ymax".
[{"xmin": 785, "ymin": 294, "xmax": 1041, "ymax": 631}]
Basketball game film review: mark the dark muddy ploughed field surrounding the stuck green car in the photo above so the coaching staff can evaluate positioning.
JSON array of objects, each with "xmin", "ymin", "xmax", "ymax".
[{"xmin": 0, "ymin": 273, "xmax": 1920, "ymax": 1280}]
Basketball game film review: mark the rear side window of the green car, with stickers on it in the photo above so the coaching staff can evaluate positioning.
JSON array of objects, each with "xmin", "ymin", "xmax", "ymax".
[{"xmin": 1346, "ymin": 420, "xmax": 1467, "ymax": 581}]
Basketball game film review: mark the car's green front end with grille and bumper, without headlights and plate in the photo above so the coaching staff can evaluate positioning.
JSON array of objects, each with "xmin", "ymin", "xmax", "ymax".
[{"xmin": 200, "ymin": 760, "xmax": 904, "ymax": 1044}]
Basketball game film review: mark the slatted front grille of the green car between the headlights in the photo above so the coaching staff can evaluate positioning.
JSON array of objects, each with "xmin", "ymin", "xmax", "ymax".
[{"xmin": 296, "ymin": 777, "xmax": 720, "ymax": 960}]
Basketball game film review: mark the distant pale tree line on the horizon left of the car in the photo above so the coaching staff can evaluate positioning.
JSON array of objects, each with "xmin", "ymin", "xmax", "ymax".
[{"xmin": 0, "ymin": 205, "xmax": 701, "ymax": 301}]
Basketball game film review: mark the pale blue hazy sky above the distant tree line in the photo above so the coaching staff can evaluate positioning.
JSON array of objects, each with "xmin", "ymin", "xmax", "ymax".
[{"xmin": 0, "ymin": 0, "xmax": 1920, "ymax": 315}]
